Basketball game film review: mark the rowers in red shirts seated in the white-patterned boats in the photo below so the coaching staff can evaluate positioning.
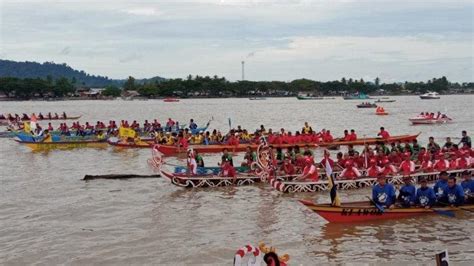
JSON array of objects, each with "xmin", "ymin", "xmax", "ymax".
[{"xmin": 206, "ymin": 131, "xmax": 474, "ymax": 182}]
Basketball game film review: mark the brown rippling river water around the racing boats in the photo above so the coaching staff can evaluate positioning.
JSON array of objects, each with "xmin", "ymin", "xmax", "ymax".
[{"xmin": 0, "ymin": 95, "xmax": 474, "ymax": 265}]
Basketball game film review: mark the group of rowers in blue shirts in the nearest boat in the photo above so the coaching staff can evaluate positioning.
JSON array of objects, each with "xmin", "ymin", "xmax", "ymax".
[{"xmin": 372, "ymin": 170, "xmax": 474, "ymax": 208}]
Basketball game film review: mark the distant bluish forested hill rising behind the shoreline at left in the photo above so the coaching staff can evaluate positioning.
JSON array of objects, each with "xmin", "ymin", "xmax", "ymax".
[{"xmin": 0, "ymin": 59, "xmax": 166, "ymax": 87}]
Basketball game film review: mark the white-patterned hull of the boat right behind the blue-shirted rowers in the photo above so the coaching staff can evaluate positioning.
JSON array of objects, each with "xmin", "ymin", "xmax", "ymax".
[{"xmin": 270, "ymin": 168, "xmax": 474, "ymax": 193}]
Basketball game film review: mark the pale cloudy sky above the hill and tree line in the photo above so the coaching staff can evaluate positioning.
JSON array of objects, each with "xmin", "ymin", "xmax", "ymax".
[{"xmin": 0, "ymin": 0, "xmax": 474, "ymax": 82}]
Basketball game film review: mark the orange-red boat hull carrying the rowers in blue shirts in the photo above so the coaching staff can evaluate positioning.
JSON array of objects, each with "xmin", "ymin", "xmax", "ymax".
[{"xmin": 300, "ymin": 200, "xmax": 474, "ymax": 223}]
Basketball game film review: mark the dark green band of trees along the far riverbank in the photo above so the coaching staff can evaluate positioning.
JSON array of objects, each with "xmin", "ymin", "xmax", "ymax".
[{"xmin": 0, "ymin": 75, "xmax": 474, "ymax": 101}]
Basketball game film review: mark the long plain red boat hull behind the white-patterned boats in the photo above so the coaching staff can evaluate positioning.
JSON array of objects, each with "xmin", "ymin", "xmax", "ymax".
[{"xmin": 158, "ymin": 133, "xmax": 420, "ymax": 156}]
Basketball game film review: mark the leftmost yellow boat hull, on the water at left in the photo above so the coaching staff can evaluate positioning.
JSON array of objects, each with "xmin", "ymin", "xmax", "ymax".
[{"xmin": 15, "ymin": 139, "xmax": 107, "ymax": 151}]
